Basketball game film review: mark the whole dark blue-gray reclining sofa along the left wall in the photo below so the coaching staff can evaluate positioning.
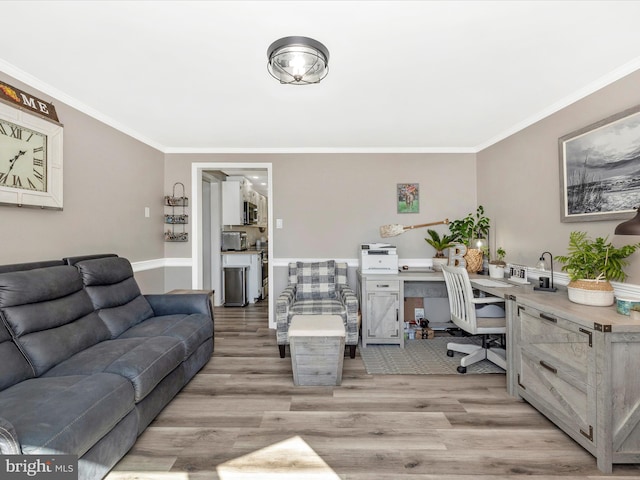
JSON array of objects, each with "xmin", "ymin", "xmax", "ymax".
[{"xmin": 0, "ymin": 254, "xmax": 213, "ymax": 480}]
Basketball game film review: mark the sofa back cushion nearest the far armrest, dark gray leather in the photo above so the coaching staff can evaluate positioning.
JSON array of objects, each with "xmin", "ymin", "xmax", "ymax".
[{"xmin": 75, "ymin": 257, "xmax": 154, "ymax": 338}]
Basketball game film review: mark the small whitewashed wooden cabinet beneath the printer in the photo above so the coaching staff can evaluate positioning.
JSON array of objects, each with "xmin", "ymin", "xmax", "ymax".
[{"xmin": 360, "ymin": 275, "xmax": 404, "ymax": 347}]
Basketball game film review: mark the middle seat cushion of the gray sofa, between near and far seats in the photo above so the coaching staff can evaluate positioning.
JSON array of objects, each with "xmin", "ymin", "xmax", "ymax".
[{"xmin": 44, "ymin": 337, "xmax": 184, "ymax": 403}]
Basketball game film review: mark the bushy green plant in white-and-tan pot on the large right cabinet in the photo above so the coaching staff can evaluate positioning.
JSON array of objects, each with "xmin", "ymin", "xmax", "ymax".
[{"xmin": 556, "ymin": 232, "xmax": 640, "ymax": 306}]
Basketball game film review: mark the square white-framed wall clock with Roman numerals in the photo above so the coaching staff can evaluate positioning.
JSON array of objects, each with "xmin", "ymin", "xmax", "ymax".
[{"xmin": 0, "ymin": 103, "xmax": 63, "ymax": 210}]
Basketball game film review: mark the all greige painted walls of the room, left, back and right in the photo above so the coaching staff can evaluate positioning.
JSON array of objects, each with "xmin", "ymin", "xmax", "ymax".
[{"xmin": 0, "ymin": 66, "xmax": 640, "ymax": 291}]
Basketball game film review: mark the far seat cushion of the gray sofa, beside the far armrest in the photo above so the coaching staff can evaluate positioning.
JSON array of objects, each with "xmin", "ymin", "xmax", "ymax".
[{"xmin": 118, "ymin": 314, "xmax": 213, "ymax": 360}]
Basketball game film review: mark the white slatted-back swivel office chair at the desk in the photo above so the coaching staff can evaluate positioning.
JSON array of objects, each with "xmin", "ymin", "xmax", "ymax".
[{"xmin": 442, "ymin": 266, "xmax": 507, "ymax": 373}]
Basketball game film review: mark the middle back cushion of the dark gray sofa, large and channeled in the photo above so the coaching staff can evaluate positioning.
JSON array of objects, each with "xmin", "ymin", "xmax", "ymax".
[{"xmin": 0, "ymin": 265, "xmax": 110, "ymax": 376}]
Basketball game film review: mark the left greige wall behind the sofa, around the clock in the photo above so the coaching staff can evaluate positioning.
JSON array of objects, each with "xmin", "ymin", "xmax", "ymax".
[{"xmin": 0, "ymin": 73, "xmax": 164, "ymax": 284}]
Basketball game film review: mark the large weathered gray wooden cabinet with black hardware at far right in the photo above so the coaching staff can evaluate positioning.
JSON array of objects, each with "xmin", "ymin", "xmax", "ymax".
[{"xmin": 507, "ymin": 293, "xmax": 640, "ymax": 473}]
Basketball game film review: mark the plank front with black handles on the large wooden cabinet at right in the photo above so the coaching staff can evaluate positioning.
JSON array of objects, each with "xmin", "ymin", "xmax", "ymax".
[{"xmin": 516, "ymin": 306, "xmax": 596, "ymax": 444}]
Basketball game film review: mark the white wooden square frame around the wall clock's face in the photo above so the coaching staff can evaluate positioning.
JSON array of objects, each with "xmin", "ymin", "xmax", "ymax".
[{"xmin": 0, "ymin": 102, "xmax": 63, "ymax": 210}]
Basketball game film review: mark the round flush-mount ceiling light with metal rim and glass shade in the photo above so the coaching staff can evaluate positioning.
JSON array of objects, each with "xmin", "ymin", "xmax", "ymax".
[{"xmin": 267, "ymin": 37, "xmax": 329, "ymax": 85}]
